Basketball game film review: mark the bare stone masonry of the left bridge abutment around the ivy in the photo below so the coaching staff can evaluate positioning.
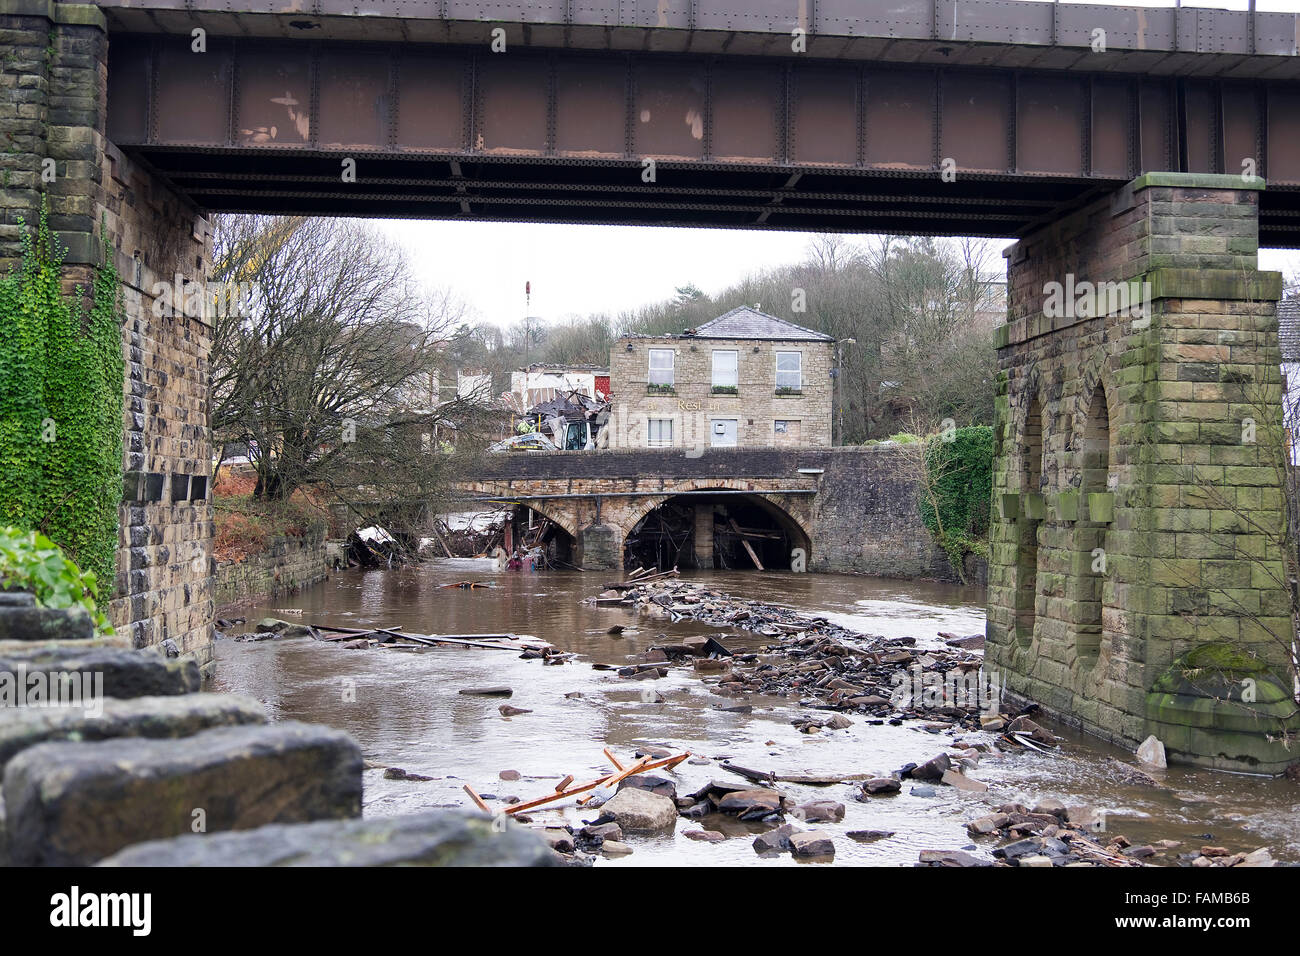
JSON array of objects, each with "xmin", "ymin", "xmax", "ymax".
[{"xmin": 0, "ymin": 0, "xmax": 212, "ymax": 669}]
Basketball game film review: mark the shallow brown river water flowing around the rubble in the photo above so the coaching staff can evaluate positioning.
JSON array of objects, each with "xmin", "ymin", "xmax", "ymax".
[{"xmin": 216, "ymin": 558, "xmax": 1300, "ymax": 866}]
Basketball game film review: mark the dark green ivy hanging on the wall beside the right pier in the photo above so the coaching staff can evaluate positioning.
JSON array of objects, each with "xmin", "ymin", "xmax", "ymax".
[{"xmin": 920, "ymin": 425, "xmax": 993, "ymax": 580}]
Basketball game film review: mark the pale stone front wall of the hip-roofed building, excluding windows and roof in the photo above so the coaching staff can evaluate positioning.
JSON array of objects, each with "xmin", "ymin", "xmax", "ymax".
[{"xmin": 610, "ymin": 336, "xmax": 833, "ymax": 447}]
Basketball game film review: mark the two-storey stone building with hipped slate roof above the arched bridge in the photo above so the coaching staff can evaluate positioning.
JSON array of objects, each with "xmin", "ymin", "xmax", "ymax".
[{"xmin": 602, "ymin": 306, "xmax": 835, "ymax": 447}]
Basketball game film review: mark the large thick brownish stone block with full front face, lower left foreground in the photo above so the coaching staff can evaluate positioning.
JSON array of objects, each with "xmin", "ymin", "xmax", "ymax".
[{"xmin": 0, "ymin": 722, "xmax": 361, "ymax": 866}]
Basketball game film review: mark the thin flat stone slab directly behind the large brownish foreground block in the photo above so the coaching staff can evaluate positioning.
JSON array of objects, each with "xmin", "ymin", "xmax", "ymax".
[{"xmin": 0, "ymin": 693, "xmax": 267, "ymax": 779}]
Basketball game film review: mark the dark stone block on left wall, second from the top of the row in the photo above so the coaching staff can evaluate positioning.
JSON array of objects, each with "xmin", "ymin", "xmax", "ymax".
[{"xmin": 0, "ymin": 644, "xmax": 200, "ymax": 708}]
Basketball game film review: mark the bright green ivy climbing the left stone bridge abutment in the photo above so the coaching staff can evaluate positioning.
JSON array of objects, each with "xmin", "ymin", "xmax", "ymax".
[{"xmin": 0, "ymin": 208, "xmax": 125, "ymax": 601}]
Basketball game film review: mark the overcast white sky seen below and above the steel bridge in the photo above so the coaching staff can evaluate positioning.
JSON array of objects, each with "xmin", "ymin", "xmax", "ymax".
[{"xmin": 376, "ymin": 0, "xmax": 1300, "ymax": 325}]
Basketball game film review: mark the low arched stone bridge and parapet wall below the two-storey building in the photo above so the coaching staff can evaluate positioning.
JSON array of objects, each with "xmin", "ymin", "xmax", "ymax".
[{"xmin": 456, "ymin": 446, "xmax": 952, "ymax": 578}]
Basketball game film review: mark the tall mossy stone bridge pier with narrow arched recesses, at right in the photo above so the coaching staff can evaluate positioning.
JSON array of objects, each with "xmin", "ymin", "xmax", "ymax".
[{"xmin": 987, "ymin": 173, "xmax": 1300, "ymax": 773}]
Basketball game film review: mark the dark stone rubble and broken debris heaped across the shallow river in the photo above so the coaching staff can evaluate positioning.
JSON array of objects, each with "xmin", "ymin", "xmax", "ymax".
[{"xmin": 517, "ymin": 579, "xmax": 1273, "ymax": 868}]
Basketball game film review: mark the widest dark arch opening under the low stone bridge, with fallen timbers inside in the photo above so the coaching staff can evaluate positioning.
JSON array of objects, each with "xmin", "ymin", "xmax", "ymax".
[{"xmin": 623, "ymin": 492, "xmax": 811, "ymax": 571}]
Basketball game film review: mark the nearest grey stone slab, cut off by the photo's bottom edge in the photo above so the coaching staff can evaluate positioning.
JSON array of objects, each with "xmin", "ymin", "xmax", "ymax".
[{"xmin": 100, "ymin": 810, "xmax": 560, "ymax": 866}]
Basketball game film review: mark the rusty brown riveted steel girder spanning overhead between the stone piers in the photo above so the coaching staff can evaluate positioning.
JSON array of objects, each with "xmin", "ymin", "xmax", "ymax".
[{"xmin": 108, "ymin": 35, "xmax": 1300, "ymax": 245}]
